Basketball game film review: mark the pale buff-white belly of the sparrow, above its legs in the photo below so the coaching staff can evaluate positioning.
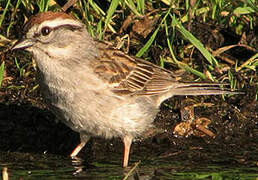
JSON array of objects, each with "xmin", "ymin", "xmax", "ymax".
[{"xmin": 42, "ymin": 85, "xmax": 158, "ymax": 138}]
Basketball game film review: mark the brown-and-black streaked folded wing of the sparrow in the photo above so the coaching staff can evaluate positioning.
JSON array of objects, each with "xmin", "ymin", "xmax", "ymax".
[{"xmin": 94, "ymin": 42, "xmax": 181, "ymax": 95}]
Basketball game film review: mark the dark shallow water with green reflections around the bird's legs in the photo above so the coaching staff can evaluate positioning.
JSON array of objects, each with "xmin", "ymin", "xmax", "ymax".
[{"xmin": 0, "ymin": 152, "xmax": 258, "ymax": 180}]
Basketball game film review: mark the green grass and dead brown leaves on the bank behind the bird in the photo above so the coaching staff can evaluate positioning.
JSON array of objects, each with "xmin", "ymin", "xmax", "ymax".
[{"xmin": 0, "ymin": 0, "xmax": 258, "ymax": 100}]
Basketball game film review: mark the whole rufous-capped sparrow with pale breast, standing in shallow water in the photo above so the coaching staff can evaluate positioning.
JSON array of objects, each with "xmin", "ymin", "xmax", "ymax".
[{"xmin": 12, "ymin": 12, "xmax": 238, "ymax": 167}]
